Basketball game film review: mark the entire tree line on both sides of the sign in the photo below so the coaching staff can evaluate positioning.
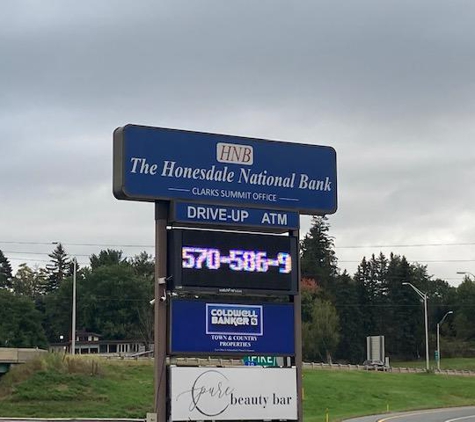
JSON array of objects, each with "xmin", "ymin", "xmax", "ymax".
[{"xmin": 0, "ymin": 217, "xmax": 475, "ymax": 363}]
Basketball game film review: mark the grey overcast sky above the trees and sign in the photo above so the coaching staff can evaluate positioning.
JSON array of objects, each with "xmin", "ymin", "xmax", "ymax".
[{"xmin": 0, "ymin": 0, "xmax": 475, "ymax": 285}]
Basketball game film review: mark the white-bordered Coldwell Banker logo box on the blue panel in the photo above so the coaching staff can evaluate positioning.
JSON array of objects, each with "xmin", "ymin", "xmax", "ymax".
[{"xmin": 206, "ymin": 303, "xmax": 263, "ymax": 336}]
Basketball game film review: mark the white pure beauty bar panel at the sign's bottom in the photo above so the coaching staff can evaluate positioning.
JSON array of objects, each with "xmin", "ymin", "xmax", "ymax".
[{"xmin": 171, "ymin": 367, "xmax": 297, "ymax": 421}]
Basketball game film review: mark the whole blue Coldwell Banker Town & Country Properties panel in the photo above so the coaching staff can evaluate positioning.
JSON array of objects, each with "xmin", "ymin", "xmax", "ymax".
[{"xmin": 170, "ymin": 299, "xmax": 295, "ymax": 356}]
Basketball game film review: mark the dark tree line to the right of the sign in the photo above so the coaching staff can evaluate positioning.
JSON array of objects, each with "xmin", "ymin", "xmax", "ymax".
[{"xmin": 300, "ymin": 217, "xmax": 475, "ymax": 363}]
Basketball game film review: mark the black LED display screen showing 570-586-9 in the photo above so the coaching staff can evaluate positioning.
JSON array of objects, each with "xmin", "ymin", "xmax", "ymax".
[{"xmin": 168, "ymin": 229, "xmax": 298, "ymax": 294}]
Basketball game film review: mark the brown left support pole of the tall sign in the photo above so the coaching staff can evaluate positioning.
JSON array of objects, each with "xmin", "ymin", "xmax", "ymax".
[{"xmin": 154, "ymin": 201, "xmax": 168, "ymax": 422}]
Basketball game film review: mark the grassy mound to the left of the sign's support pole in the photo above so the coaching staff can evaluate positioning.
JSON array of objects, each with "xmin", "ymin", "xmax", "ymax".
[{"xmin": 0, "ymin": 359, "xmax": 153, "ymax": 418}]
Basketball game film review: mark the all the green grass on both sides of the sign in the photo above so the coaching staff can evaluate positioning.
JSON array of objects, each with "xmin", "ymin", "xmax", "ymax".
[{"xmin": 0, "ymin": 355, "xmax": 475, "ymax": 422}]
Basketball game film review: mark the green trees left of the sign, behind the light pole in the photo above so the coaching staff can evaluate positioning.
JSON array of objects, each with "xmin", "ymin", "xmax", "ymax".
[{"xmin": 0, "ymin": 244, "xmax": 154, "ymax": 348}]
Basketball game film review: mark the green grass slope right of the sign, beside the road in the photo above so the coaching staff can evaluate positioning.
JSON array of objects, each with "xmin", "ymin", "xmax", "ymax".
[{"xmin": 304, "ymin": 370, "xmax": 475, "ymax": 422}]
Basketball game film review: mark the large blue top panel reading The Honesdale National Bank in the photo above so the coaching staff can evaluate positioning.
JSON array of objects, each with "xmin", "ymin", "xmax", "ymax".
[{"xmin": 114, "ymin": 125, "xmax": 337, "ymax": 214}]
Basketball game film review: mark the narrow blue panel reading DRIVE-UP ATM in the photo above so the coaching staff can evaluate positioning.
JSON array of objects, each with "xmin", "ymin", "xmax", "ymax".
[{"xmin": 172, "ymin": 201, "xmax": 299, "ymax": 230}]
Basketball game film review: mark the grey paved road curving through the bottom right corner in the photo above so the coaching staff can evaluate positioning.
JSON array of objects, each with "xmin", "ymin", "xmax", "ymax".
[{"xmin": 346, "ymin": 407, "xmax": 475, "ymax": 422}]
